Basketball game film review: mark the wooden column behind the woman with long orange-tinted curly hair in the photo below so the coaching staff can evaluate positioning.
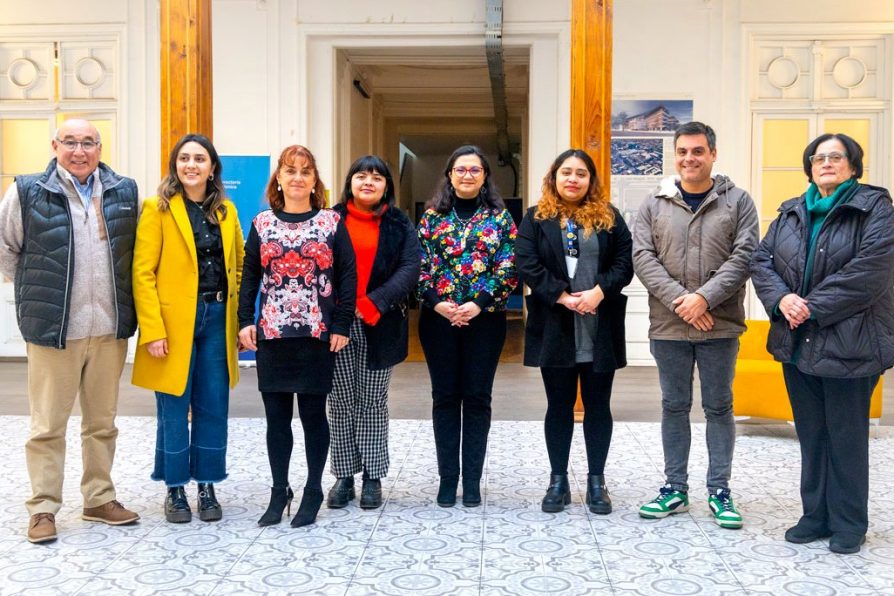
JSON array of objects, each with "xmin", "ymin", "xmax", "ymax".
[{"xmin": 571, "ymin": 0, "xmax": 613, "ymax": 421}]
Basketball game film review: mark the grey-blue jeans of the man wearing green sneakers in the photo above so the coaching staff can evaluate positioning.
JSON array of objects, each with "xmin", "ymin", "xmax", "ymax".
[{"xmin": 650, "ymin": 338, "xmax": 739, "ymax": 492}]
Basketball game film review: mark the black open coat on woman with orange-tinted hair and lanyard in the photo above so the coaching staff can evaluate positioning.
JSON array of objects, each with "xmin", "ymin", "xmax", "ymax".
[{"xmin": 515, "ymin": 207, "xmax": 633, "ymax": 372}]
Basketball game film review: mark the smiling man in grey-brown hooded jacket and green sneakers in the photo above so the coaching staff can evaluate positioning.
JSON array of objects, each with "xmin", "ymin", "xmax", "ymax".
[{"xmin": 633, "ymin": 122, "xmax": 758, "ymax": 528}]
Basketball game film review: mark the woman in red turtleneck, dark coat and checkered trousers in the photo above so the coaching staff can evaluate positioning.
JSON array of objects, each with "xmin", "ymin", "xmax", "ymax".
[{"xmin": 327, "ymin": 155, "xmax": 420, "ymax": 509}]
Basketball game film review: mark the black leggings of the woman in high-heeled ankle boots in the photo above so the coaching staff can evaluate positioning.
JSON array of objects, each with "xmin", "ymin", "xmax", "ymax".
[{"xmin": 261, "ymin": 392, "xmax": 329, "ymax": 490}]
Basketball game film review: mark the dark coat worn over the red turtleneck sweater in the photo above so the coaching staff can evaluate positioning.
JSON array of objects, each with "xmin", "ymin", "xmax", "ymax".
[{"xmin": 333, "ymin": 203, "xmax": 421, "ymax": 370}]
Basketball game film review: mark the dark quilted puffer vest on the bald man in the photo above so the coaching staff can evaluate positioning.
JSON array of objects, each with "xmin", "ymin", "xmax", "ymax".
[{"xmin": 15, "ymin": 159, "xmax": 139, "ymax": 349}]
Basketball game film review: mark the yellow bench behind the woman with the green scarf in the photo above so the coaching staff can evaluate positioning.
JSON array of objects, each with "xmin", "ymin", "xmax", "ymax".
[{"xmin": 733, "ymin": 320, "xmax": 883, "ymax": 421}]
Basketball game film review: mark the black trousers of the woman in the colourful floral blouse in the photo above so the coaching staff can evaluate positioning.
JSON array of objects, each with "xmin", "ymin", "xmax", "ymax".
[{"xmin": 419, "ymin": 307, "xmax": 506, "ymax": 481}]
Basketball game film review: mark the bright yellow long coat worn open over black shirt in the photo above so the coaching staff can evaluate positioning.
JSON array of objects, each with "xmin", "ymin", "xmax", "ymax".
[{"xmin": 132, "ymin": 195, "xmax": 243, "ymax": 395}]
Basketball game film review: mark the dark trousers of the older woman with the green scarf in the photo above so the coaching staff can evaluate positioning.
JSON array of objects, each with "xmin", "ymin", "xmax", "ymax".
[{"xmin": 782, "ymin": 364, "xmax": 879, "ymax": 534}]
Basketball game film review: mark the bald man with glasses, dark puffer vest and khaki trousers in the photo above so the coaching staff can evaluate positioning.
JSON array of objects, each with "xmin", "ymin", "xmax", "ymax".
[{"xmin": 0, "ymin": 120, "xmax": 140, "ymax": 542}]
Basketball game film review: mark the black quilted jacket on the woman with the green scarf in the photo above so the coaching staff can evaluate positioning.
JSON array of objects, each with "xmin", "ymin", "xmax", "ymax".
[{"xmin": 751, "ymin": 185, "xmax": 894, "ymax": 378}]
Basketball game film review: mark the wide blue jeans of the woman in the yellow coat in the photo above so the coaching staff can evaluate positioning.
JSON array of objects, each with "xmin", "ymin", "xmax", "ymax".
[{"xmin": 152, "ymin": 302, "xmax": 230, "ymax": 486}]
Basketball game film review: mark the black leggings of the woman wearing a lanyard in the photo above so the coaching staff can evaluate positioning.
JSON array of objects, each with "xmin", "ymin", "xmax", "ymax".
[{"xmin": 540, "ymin": 362, "xmax": 615, "ymax": 474}]
